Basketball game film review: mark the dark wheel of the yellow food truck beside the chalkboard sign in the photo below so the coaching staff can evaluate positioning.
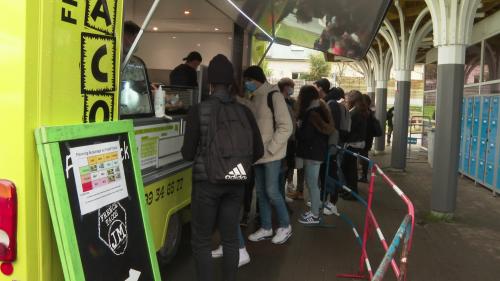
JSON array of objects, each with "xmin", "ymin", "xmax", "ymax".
[{"xmin": 158, "ymin": 213, "xmax": 182, "ymax": 265}]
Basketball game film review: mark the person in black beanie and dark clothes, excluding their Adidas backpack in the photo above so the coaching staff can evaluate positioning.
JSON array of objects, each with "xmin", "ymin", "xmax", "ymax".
[{"xmin": 181, "ymin": 55, "xmax": 264, "ymax": 281}]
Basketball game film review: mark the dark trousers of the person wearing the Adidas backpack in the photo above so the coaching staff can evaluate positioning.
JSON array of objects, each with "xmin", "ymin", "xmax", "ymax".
[{"xmin": 191, "ymin": 182, "xmax": 245, "ymax": 281}]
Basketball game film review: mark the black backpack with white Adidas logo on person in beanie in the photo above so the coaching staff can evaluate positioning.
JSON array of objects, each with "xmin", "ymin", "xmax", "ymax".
[{"xmin": 205, "ymin": 100, "xmax": 253, "ymax": 184}]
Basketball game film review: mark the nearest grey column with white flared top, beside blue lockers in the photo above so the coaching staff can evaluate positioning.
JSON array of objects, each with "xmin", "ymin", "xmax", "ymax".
[{"xmin": 425, "ymin": 0, "xmax": 481, "ymax": 217}]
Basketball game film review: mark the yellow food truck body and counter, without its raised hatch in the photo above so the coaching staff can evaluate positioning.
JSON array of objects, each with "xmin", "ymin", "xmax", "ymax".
[{"xmin": 0, "ymin": 0, "xmax": 201, "ymax": 281}]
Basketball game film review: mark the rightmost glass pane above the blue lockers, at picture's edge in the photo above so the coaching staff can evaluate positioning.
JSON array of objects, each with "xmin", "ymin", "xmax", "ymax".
[{"xmin": 483, "ymin": 34, "xmax": 500, "ymax": 81}]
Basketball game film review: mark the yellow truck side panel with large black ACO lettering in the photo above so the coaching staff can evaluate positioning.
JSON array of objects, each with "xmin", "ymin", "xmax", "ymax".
[{"xmin": 42, "ymin": 0, "xmax": 123, "ymax": 125}]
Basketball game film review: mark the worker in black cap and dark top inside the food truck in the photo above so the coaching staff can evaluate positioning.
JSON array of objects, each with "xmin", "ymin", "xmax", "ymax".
[{"xmin": 170, "ymin": 51, "xmax": 202, "ymax": 87}]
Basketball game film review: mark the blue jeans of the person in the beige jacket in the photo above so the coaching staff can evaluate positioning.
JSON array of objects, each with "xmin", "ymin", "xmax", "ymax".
[{"xmin": 255, "ymin": 160, "xmax": 290, "ymax": 230}]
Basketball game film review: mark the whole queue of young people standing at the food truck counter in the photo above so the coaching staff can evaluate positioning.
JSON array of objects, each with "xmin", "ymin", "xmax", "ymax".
[{"xmin": 182, "ymin": 55, "xmax": 380, "ymax": 281}]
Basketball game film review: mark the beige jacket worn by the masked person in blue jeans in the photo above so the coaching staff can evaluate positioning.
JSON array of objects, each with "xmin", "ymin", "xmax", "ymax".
[{"xmin": 252, "ymin": 82, "xmax": 293, "ymax": 164}]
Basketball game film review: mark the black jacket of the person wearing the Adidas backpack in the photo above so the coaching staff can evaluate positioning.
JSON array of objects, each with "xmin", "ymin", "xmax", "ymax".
[{"xmin": 181, "ymin": 92, "xmax": 264, "ymax": 181}]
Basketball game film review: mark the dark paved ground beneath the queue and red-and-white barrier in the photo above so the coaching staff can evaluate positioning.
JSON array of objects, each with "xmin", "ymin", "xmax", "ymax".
[{"xmin": 162, "ymin": 148, "xmax": 500, "ymax": 281}]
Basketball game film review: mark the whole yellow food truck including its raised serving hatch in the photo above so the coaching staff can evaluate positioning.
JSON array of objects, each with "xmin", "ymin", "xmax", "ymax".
[{"xmin": 0, "ymin": 0, "xmax": 390, "ymax": 281}]
